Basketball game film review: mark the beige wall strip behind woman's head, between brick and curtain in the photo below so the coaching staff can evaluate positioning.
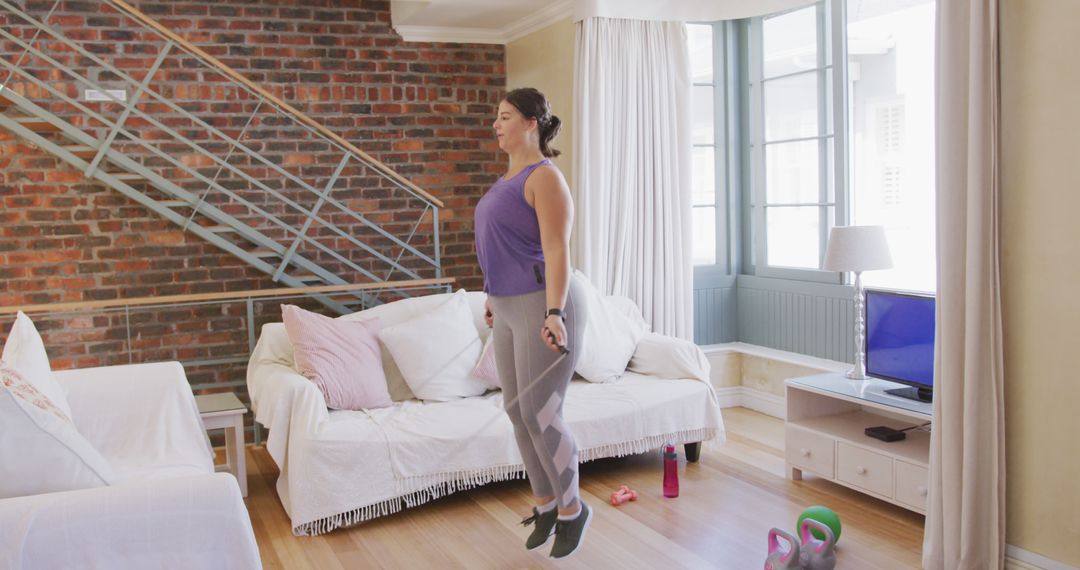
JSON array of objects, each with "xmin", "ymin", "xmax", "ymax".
[{"xmin": 507, "ymin": 18, "xmax": 575, "ymax": 191}]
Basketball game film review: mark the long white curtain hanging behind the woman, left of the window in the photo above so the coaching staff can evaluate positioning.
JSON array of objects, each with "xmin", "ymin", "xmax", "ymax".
[{"xmin": 572, "ymin": 17, "xmax": 693, "ymax": 340}]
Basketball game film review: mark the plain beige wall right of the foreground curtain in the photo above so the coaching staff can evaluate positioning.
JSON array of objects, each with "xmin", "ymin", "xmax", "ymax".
[{"xmin": 1001, "ymin": 0, "xmax": 1080, "ymax": 567}]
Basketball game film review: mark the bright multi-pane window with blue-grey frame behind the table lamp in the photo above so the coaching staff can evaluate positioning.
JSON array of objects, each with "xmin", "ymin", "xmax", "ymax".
[{"xmin": 690, "ymin": 0, "xmax": 935, "ymax": 290}]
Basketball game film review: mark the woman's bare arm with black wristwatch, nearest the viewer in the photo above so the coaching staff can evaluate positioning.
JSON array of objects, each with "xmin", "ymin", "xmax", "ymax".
[{"xmin": 525, "ymin": 167, "xmax": 573, "ymax": 350}]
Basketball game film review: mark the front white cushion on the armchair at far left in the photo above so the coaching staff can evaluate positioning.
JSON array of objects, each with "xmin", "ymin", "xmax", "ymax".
[{"xmin": 0, "ymin": 363, "xmax": 112, "ymax": 499}]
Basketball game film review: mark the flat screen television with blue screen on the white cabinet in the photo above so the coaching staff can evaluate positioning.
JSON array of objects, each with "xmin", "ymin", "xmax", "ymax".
[{"xmin": 866, "ymin": 289, "xmax": 934, "ymax": 402}]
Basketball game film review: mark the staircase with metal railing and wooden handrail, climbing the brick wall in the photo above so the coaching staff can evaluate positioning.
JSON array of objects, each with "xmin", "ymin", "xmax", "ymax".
[{"xmin": 0, "ymin": 0, "xmax": 451, "ymax": 314}]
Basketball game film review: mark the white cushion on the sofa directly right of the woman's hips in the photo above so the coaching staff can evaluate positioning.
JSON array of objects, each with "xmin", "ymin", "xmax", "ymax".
[{"xmin": 571, "ymin": 271, "xmax": 646, "ymax": 382}]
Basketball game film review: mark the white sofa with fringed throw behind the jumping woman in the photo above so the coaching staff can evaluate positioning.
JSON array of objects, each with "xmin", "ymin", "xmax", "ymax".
[{"xmin": 247, "ymin": 293, "xmax": 724, "ymax": 535}]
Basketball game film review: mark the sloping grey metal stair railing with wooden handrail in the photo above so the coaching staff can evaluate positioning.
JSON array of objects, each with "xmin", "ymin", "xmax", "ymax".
[{"xmin": 0, "ymin": 0, "xmax": 443, "ymax": 310}]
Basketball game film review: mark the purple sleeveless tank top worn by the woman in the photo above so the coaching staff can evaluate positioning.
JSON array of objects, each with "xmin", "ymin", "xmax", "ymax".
[{"xmin": 474, "ymin": 159, "xmax": 551, "ymax": 297}]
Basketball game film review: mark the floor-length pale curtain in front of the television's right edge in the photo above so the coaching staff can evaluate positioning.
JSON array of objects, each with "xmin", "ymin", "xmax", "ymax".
[{"xmin": 922, "ymin": 0, "xmax": 1005, "ymax": 570}]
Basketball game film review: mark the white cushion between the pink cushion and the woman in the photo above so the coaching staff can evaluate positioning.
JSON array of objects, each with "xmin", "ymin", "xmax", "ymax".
[{"xmin": 379, "ymin": 290, "xmax": 487, "ymax": 402}]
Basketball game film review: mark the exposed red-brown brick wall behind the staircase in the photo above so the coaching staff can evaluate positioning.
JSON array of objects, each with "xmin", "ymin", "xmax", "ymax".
[{"xmin": 0, "ymin": 0, "xmax": 505, "ymax": 418}]
